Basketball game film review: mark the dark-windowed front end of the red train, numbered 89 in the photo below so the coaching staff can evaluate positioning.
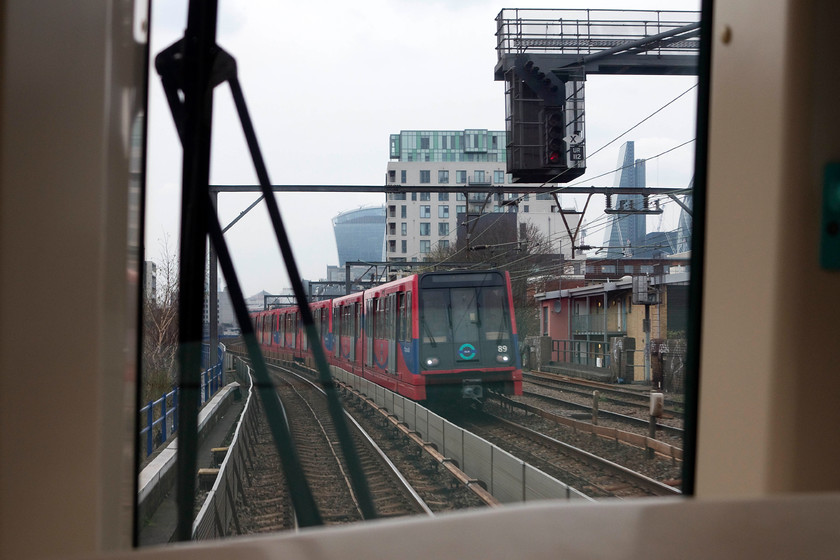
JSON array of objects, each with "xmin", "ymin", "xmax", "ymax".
[{"xmin": 417, "ymin": 271, "xmax": 522, "ymax": 403}]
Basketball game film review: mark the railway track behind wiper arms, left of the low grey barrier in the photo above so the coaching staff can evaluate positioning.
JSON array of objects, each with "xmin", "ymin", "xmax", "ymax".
[{"xmin": 233, "ymin": 366, "xmax": 497, "ymax": 533}]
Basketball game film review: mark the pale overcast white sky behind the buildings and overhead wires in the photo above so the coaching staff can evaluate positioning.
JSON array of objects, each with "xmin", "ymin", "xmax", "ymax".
[{"xmin": 146, "ymin": 0, "xmax": 699, "ymax": 296}]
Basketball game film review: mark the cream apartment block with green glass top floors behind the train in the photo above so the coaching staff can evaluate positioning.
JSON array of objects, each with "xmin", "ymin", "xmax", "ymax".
[{"xmin": 385, "ymin": 129, "xmax": 578, "ymax": 261}]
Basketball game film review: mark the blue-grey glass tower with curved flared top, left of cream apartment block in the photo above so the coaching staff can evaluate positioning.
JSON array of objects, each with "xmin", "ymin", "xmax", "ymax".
[{"xmin": 332, "ymin": 206, "xmax": 385, "ymax": 266}]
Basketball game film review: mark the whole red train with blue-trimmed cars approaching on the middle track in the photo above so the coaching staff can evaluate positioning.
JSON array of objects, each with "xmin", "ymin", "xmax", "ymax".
[{"xmin": 252, "ymin": 271, "xmax": 522, "ymax": 402}]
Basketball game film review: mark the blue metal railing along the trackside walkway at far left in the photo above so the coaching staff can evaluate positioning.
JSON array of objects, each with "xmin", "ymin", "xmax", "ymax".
[{"xmin": 139, "ymin": 345, "xmax": 225, "ymax": 457}]
